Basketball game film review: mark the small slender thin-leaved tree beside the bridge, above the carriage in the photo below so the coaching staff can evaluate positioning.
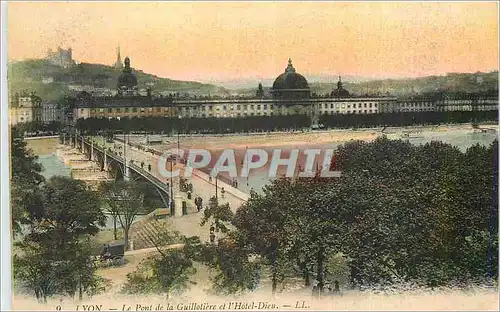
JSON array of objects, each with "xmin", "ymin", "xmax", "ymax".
[{"xmin": 101, "ymin": 181, "xmax": 144, "ymax": 249}]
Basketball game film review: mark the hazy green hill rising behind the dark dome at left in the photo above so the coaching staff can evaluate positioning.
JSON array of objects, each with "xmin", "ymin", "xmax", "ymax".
[{"xmin": 7, "ymin": 59, "xmax": 228, "ymax": 100}]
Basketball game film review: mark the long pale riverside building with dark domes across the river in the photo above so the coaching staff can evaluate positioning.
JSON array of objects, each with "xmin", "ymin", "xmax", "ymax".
[{"xmin": 71, "ymin": 57, "xmax": 498, "ymax": 124}]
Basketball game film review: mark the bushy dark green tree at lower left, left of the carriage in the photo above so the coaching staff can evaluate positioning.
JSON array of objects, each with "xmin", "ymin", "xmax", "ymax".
[{"xmin": 14, "ymin": 177, "xmax": 106, "ymax": 301}]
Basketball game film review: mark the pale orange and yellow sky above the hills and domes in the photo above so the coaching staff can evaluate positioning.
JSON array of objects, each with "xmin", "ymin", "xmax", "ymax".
[{"xmin": 7, "ymin": 1, "xmax": 499, "ymax": 81}]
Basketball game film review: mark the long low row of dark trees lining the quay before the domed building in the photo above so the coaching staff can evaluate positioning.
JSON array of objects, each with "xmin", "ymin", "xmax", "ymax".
[{"xmin": 72, "ymin": 110, "xmax": 498, "ymax": 134}]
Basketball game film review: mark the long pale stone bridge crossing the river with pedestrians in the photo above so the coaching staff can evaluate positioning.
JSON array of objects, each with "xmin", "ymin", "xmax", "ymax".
[{"xmin": 60, "ymin": 134, "xmax": 249, "ymax": 216}]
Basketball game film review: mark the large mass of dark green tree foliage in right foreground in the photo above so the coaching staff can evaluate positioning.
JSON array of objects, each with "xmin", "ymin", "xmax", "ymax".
[{"xmin": 232, "ymin": 138, "xmax": 498, "ymax": 291}]
